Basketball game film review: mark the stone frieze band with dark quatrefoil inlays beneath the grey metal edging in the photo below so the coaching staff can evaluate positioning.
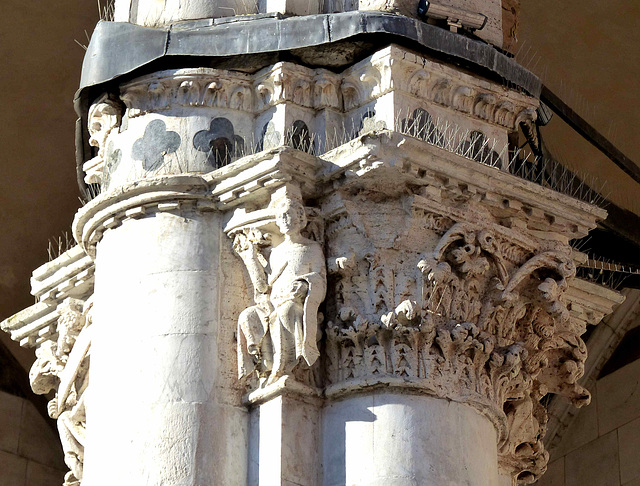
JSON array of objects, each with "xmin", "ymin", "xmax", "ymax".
[{"xmin": 84, "ymin": 45, "xmax": 538, "ymax": 190}]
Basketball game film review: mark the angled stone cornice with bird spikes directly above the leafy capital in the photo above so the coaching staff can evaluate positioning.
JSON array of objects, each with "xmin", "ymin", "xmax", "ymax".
[{"xmin": 321, "ymin": 131, "xmax": 607, "ymax": 243}]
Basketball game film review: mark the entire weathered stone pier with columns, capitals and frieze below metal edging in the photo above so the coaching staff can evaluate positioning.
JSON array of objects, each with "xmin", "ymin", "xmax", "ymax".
[{"xmin": 3, "ymin": 45, "xmax": 619, "ymax": 486}]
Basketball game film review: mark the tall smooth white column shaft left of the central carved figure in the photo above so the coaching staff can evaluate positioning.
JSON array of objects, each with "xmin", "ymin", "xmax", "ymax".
[{"xmin": 82, "ymin": 201, "xmax": 247, "ymax": 486}]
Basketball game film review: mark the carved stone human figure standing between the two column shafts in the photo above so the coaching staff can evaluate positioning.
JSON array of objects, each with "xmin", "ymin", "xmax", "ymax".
[{"xmin": 234, "ymin": 199, "xmax": 326, "ymax": 384}]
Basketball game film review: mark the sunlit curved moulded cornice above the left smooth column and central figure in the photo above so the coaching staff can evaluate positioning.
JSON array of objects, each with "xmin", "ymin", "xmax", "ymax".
[{"xmin": 73, "ymin": 147, "xmax": 318, "ymax": 257}]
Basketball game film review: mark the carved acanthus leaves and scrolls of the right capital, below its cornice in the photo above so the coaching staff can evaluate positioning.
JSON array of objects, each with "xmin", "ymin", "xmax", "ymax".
[{"xmin": 326, "ymin": 211, "xmax": 589, "ymax": 483}]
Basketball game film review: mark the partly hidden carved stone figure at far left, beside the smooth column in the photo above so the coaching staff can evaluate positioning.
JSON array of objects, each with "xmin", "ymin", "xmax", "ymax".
[{"xmin": 30, "ymin": 301, "xmax": 91, "ymax": 486}]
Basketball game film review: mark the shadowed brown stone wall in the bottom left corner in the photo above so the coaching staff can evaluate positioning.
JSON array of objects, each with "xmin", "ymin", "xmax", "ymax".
[{"xmin": 0, "ymin": 391, "xmax": 65, "ymax": 486}]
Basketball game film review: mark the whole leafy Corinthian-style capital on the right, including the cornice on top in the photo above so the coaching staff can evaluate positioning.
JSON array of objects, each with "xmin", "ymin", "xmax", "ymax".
[{"xmin": 321, "ymin": 135, "xmax": 613, "ymax": 484}]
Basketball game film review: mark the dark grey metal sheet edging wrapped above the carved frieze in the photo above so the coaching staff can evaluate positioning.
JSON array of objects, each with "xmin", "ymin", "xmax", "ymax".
[{"xmin": 76, "ymin": 11, "xmax": 542, "ymax": 98}]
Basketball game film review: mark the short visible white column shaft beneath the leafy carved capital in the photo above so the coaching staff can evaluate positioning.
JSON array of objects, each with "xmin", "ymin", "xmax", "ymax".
[{"xmin": 322, "ymin": 390, "xmax": 498, "ymax": 486}]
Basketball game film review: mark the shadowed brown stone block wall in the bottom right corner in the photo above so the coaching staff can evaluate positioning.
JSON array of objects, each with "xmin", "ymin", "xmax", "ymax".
[{"xmin": 536, "ymin": 338, "xmax": 640, "ymax": 486}]
